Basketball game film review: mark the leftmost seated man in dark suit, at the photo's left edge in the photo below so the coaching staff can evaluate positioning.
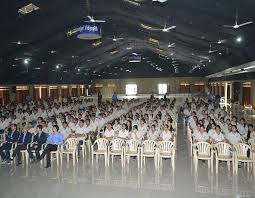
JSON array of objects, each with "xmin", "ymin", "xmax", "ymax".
[{"xmin": 0, "ymin": 124, "xmax": 20, "ymax": 164}]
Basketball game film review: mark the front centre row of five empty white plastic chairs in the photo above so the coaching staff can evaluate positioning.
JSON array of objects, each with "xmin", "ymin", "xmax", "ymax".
[{"xmin": 91, "ymin": 138, "xmax": 175, "ymax": 170}]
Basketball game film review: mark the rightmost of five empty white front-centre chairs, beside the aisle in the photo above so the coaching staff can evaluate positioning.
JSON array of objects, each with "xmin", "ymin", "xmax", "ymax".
[{"xmin": 158, "ymin": 141, "xmax": 175, "ymax": 171}]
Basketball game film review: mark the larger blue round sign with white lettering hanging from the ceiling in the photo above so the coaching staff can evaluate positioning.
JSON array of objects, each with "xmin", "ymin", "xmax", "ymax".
[{"xmin": 77, "ymin": 22, "xmax": 102, "ymax": 40}]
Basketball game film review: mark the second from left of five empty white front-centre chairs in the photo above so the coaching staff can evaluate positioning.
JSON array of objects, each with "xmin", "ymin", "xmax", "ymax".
[{"xmin": 108, "ymin": 138, "xmax": 124, "ymax": 167}]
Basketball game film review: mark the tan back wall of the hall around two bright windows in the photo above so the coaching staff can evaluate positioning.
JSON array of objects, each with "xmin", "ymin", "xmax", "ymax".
[{"xmin": 93, "ymin": 77, "xmax": 207, "ymax": 96}]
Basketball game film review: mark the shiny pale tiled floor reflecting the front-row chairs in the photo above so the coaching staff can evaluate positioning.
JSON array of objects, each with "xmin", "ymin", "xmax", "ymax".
[{"xmin": 0, "ymin": 120, "xmax": 255, "ymax": 198}]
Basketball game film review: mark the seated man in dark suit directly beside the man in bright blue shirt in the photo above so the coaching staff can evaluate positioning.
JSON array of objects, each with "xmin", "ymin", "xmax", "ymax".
[{"xmin": 27, "ymin": 125, "xmax": 47, "ymax": 162}]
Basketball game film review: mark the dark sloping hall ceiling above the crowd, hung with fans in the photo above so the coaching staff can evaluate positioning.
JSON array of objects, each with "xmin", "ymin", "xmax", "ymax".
[{"xmin": 0, "ymin": 0, "xmax": 255, "ymax": 83}]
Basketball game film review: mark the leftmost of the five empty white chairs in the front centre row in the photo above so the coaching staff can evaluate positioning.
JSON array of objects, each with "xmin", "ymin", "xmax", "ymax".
[{"xmin": 91, "ymin": 138, "xmax": 109, "ymax": 166}]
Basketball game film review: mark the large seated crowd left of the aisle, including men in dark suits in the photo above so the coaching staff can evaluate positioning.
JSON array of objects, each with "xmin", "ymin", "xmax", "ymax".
[{"xmin": 0, "ymin": 96, "xmax": 177, "ymax": 168}]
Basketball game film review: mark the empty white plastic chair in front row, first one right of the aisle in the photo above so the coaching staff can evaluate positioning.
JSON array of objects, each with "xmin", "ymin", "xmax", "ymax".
[{"xmin": 194, "ymin": 142, "xmax": 213, "ymax": 172}]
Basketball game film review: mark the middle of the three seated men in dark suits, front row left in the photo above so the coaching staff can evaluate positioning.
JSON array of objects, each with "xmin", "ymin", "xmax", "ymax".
[{"xmin": 11, "ymin": 127, "xmax": 32, "ymax": 165}]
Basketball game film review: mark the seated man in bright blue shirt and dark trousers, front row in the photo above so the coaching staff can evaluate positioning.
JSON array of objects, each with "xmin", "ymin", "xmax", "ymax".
[{"xmin": 40, "ymin": 125, "xmax": 64, "ymax": 168}]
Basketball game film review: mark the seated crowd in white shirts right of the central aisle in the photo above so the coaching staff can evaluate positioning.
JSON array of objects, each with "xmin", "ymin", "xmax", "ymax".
[{"xmin": 183, "ymin": 99, "xmax": 255, "ymax": 145}]
